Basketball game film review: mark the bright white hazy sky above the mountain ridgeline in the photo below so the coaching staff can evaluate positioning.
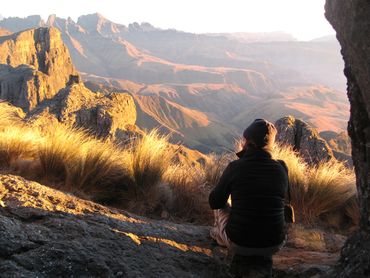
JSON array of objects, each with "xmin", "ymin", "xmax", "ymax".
[{"xmin": 0, "ymin": 0, "xmax": 334, "ymax": 40}]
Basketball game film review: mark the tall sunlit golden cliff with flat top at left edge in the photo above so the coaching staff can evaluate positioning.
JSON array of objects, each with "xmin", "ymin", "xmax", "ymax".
[{"xmin": 0, "ymin": 28, "xmax": 78, "ymax": 111}]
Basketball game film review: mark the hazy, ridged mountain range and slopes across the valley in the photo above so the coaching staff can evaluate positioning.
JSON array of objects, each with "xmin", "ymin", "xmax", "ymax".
[{"xmin": 0, "ymin": 14, "xmax": 349, "ymax": 152}]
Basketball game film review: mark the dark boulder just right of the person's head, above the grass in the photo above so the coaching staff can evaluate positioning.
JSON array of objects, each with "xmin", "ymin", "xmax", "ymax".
[{"xmin": 275, "ymin": 116, "xmax": 334, "ymax": 164}]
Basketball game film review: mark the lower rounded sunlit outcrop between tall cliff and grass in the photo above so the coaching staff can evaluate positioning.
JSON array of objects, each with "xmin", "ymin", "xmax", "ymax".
[{"xmin": 29, "ymin": 83, "xmax": 136, "ymax": 138}]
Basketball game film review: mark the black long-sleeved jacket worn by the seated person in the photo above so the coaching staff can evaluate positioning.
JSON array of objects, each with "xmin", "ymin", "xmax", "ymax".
[{"xmin": 209, "ymin": 148, "xmax": 288, "ymax": 248}]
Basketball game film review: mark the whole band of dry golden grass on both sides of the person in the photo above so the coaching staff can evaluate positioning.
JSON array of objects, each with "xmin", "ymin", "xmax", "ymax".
[{"xmin": 0, "ymin": 104, "xmax": 359, "ymax": 229}]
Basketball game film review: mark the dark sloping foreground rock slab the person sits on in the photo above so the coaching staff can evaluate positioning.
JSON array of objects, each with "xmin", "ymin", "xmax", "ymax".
[{"xmin": 0, "ymin": 175, "xmax": 343, "ymax": 278}]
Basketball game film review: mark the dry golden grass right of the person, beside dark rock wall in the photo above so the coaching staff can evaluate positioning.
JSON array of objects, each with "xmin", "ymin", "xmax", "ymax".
[{"xmin": 273, "ymin": 143, "xmax": 357, "ymax": 225}]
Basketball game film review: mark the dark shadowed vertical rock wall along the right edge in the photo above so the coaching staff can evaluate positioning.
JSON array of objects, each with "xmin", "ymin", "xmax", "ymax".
[{"xmin": 325, "ymin": 0, "xmax": 370, "ymax": 277}]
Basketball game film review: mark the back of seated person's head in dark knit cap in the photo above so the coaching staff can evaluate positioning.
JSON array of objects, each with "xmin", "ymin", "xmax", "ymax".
[{"xmin": 243, "ymin": 119, "xmax": 277, "ymax": 151}]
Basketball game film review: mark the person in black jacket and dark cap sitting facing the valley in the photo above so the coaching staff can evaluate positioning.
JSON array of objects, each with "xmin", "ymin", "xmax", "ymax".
[{"xmin": 209, "ymin": 119, "xmax": 288, "ymax": 277}]
